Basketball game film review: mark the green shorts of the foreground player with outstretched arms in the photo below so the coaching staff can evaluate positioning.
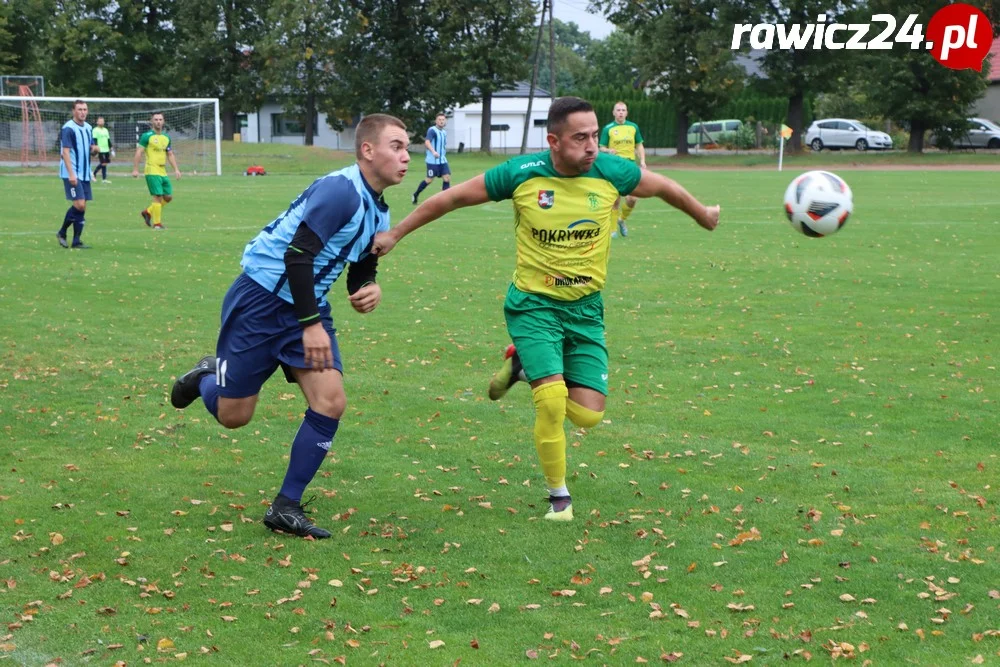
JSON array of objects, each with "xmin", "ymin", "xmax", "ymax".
[{"xmin": 503, "ymin": 285, "xmax": 608, "ymax": 396}]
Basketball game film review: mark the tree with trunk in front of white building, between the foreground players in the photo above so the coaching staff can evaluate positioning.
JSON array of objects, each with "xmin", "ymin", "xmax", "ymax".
[{"xmin": 445, "ymin": 0, "xmax": 535, "ymax": 153}]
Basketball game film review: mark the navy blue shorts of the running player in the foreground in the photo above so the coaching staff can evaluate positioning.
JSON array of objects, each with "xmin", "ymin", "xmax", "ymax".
[{"xmin": 215, "ymin": 273, "xmax": 344, "ymax": 398}]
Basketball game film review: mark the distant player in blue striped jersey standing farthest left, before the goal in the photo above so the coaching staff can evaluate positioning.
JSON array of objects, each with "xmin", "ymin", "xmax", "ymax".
[{"xmin": 56, "ymin": 100, "xmax": 97, "ymax": 249}]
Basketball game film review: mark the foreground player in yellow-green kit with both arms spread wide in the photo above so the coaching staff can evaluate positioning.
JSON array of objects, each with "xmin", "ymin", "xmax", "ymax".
[{"xmin": 372, "ymin": 97, "xmax": 719, "ymax": 521}]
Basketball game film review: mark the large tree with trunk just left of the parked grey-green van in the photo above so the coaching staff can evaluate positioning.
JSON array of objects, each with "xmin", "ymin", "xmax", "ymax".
[{"xmin": 594, "ymin": 0, "xmax": 743, "ymax": 155}]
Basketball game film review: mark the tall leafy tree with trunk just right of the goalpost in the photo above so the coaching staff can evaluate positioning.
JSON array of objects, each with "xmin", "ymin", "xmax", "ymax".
[{"xmin": 174, "ymin": 0, "xmax": 271, "ymax": 137}]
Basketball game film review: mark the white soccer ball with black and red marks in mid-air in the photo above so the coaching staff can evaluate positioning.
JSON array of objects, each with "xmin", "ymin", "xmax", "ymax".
[{"xmin": 785, "ymin": 171, "xmax": 854, "ymax": 237}]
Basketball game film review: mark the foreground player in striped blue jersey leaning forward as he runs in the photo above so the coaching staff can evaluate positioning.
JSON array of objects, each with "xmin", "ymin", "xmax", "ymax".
[{"xmin": 170, "ymin": 114, "xmax": 410, "ymax": 538}]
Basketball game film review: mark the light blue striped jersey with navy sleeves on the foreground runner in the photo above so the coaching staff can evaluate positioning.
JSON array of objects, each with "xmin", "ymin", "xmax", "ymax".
[{"xmin": 241, "ymin": 164, "xmax": 389, "ymax": 306}]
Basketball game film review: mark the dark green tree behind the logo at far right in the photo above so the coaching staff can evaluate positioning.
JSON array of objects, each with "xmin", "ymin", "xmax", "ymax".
[{"xmin": 864, "ymin": 0, "xmax": 989, "ymax": 153}]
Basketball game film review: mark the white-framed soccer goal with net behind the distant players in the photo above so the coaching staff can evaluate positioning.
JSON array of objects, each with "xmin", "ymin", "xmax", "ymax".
[{"xmin": 0, "ymin": 97, "xmax": 222, "ymax": 175}]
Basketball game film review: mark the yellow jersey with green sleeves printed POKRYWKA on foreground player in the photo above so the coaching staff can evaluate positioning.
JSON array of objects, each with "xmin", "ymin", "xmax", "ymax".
[{"xmin": 485, "ymin": 151, "xmax": 642, "ymax": 301}]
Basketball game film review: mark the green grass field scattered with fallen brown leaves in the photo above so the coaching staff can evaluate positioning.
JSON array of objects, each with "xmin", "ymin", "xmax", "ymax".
[{"xmin": 0, "ymin": 147, "xmax": 1000, "ymax": 665}]
